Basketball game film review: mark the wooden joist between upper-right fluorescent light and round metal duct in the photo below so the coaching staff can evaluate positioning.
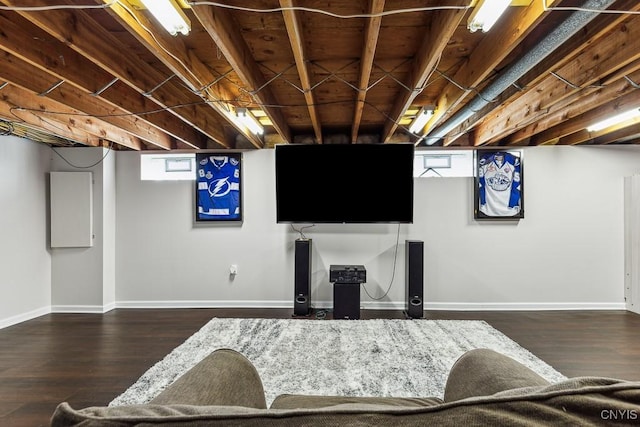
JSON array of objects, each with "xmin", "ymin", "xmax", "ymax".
[{"xmin": 425, "ymin": 1, "xmax": 545, "ymax": 141}]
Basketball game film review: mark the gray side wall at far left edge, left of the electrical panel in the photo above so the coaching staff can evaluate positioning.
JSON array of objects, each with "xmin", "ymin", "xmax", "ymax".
[{"xmin": 0, "ymin": 136, "xmax": 51, "ymax": 328}]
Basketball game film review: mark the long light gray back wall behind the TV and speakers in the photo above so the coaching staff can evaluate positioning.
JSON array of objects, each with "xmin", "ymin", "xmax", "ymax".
[{"xmin": 116, "ymin": 147, "xmax": 640, "ymax": 309}]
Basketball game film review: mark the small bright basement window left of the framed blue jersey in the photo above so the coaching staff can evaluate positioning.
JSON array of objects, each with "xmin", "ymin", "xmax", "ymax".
[{"xmin": 140, "ymin": 154, "xmax": 196, "ymax": 181}]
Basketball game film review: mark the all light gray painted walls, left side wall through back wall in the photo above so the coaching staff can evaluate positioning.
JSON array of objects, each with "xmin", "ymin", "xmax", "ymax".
[{"xmin": 0, "ymin": 137, "xmax": 640, "ymax": 327}]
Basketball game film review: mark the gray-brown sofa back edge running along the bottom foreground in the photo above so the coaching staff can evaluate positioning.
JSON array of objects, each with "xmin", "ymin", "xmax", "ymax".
[{"xmin": 51, "ymin": 378, "xmax": 640, "ymax": 427}]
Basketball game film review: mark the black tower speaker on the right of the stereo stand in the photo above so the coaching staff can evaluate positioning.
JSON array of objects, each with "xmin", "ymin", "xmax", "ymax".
[{"xmin": 405, "ymin": 240, "xmax": 424, "ymax": 318}]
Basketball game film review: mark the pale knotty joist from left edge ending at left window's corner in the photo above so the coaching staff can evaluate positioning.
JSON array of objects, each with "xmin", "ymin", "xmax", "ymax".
[{"xmin": 0, "ymin": 84, "xmax": 144, "ymax": 150}]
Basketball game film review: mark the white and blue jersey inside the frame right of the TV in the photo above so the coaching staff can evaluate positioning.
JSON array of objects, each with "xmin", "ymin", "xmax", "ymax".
[{"xmin": 478, "ymin": 152, "xmax": 521, "ymax": 217}]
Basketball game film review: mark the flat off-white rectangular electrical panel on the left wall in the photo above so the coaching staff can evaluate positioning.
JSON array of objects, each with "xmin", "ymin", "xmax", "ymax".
[{"xmin": 50, "ymin": 172, "xmax": 93, "ymax": 248}]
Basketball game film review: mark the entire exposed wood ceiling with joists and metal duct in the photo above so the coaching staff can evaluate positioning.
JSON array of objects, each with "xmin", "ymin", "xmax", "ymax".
[{"xmin": 0, "ymin": 0, "xmax": 640, "ymax": 150}]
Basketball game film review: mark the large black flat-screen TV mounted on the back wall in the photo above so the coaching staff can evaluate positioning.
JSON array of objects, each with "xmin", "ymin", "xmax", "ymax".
[{"xmin": 275, "ymin": 143, "xmax": 414, "ymax": 223}]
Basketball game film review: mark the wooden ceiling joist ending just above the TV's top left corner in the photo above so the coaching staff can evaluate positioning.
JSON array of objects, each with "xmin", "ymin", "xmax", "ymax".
[{"xmin": 192, "ymin": 5, "xmax": 292, "ymax": 142}]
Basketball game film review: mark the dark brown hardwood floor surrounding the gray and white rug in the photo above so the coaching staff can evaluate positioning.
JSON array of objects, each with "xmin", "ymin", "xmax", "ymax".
[{"xmin": 0, "ymin": 309, "xmax": 640, "ymax": 427}]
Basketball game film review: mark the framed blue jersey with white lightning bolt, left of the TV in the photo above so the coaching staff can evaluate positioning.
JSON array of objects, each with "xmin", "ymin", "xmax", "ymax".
[{"xmin": 194, "ymin": 152, "xmax": 243, "ymax": 224}]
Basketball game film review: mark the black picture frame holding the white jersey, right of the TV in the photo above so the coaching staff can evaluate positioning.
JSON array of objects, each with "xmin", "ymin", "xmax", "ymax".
[{"xmin": 474, "ymin": 150, "xmax": 524, "ymax": 220}]
